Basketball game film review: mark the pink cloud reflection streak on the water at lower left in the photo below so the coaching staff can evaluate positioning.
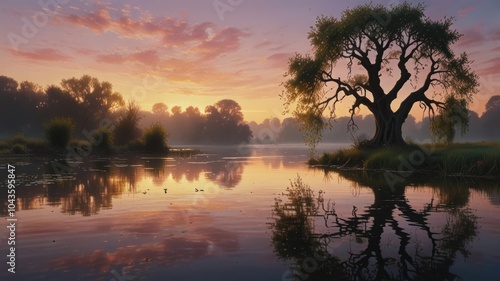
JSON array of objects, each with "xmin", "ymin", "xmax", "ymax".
[{"xmin": 50, "ymin": 222, "xmax": 239, "ymax": 276}]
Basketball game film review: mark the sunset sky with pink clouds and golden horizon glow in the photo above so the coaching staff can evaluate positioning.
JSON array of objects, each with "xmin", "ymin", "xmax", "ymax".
[{"xmin": 0, "ymin": 0, "xmax": 500, "ymax": 122}]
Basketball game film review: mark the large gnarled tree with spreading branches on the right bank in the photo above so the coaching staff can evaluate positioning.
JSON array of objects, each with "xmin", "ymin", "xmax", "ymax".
[{"xmin": 282, "ymin": 3, "xmax": 478, "ymax": 146}]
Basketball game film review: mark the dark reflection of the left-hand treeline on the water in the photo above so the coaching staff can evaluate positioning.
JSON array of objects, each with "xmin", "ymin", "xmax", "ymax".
[{"xmin": 0, "ymin": 155, "xmax": 245, "ymax": 216}]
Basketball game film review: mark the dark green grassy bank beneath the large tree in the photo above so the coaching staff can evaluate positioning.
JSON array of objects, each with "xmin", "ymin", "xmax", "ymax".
[{"xmin": 309, "ymin": 142, "xmax": 500, "ymax": 178}]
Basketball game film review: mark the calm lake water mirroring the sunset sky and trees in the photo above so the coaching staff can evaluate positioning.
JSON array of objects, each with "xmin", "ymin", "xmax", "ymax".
[{"xmin": 0, "ymin": 145, "xmax": 500, "ymax": 281}]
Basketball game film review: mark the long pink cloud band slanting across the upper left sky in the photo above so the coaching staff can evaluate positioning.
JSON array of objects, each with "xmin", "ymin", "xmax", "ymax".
[{"xmin": 59, "ymin": 6, "xmax": 248, "ymax": 58}]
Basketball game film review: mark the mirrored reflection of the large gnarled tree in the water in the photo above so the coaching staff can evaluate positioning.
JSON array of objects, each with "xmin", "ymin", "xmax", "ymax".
[{"xmin": 271, "ymin": 174, "xmax": 477, "ymax": 280}]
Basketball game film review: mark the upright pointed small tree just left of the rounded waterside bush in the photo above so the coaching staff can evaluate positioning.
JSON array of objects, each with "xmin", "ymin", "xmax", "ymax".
[{"xmin": 114, "ymin": 102, "xmax": 141, "ymax": 145}]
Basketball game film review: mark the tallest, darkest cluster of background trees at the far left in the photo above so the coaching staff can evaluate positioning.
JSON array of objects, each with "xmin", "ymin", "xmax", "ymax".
[{"xmin": 0, "ymin": 75, "xmax": 124, "ymax": 137}]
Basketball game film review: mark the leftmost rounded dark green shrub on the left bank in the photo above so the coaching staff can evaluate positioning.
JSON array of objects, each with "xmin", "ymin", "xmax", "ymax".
[{"xmin": 43, "ymin": 117, "xmax": 75, "ymax": 148}]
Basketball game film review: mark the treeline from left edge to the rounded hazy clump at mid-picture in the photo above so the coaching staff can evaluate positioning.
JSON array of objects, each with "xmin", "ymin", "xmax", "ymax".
[{"xmin": 0, "ymin": 75, "xmax": 252, "ymax": 145}]
